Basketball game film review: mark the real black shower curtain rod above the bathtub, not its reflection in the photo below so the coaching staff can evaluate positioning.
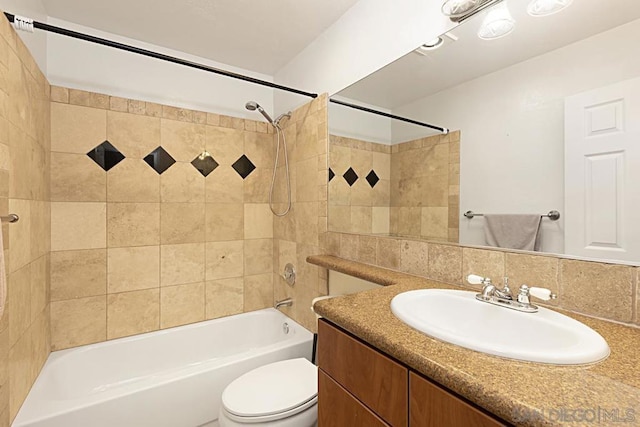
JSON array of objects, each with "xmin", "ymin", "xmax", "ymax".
[{"xmin": 4, "ymin": 12, "xmax": 318, "ymax": 98}]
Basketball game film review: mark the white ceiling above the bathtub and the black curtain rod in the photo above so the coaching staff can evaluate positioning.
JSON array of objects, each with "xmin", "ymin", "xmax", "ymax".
[{"xmin": 41, "ymin": 0, "xmax": 358, "ymax": 75}]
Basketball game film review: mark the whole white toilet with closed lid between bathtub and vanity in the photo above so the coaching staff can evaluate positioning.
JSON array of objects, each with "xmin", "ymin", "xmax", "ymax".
[{"xmin": 218, "ymin": 358, "xmax": 318, "ymax": 427}]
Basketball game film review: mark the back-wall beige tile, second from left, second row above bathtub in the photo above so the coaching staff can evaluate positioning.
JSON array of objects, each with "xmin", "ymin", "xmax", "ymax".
[{"xmin": 107, "ymin": 246, "xmax": 160, "ymax": 294}]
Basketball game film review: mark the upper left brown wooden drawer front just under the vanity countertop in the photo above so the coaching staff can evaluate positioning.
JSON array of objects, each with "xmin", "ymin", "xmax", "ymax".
[{"xmin": 318, "ymin": 319, "xmax": 409, "ymax": 427}]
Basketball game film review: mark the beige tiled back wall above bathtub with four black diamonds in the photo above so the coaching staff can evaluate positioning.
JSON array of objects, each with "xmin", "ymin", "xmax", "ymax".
[{"xmin": 51, "ymin": 87, "xmax": 274, "ymax": 350}]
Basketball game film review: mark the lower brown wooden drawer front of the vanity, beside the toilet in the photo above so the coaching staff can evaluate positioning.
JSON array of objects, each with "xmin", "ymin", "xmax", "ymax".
[{"xmin": 318, "ymin": 370, "xmax": 389, "ymax": 427}]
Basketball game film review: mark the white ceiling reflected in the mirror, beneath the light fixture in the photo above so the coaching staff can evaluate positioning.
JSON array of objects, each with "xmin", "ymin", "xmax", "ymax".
[{"xmin": 338, "ymin": 0, "xmax": 640, "ymax": 110}]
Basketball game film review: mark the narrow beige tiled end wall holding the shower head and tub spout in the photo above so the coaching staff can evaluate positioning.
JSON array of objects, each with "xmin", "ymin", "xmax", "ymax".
[{"xmin": 273, "ymin": 95, "xmax": 328, "ymax": 331}]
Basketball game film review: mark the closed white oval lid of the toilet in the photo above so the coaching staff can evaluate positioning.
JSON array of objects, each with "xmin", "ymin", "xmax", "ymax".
[{"xmin": 222, "ymin": 358, "xmax": 318, "ymax": 417}]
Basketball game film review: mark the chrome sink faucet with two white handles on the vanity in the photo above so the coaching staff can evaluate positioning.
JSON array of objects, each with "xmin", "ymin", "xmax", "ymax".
[{"xmin": 467, "ymin": 274, "xmax": 557, "ymax": 313}]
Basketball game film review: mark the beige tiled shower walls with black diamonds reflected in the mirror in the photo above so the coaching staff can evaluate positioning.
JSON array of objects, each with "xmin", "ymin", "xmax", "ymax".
[{"xmin": 329, "ymin": 131, "xmax": 460, "ymax": 242}]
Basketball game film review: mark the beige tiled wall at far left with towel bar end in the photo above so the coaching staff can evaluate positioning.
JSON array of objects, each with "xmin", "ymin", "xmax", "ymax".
[{"xmin": 0, "ymin": 15, "xmax": 50, "ymax": 426}]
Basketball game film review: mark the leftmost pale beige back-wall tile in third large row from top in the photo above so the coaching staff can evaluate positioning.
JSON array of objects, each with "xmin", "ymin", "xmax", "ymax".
[{"xmin": 51, "ymin": 202, "xmax": 107, "ymax": 251}]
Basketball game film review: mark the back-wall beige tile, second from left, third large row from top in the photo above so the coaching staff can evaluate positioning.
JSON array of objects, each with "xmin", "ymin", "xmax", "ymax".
[{"xmin": 107, "ymin": 203, "xmax": 160, "ymax": 247}]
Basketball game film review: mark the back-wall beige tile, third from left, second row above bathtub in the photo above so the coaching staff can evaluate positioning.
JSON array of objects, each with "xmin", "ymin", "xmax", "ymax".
[{"xmin": 160, "ymin": 243, "xmax": 205, "ymax": 286}]
